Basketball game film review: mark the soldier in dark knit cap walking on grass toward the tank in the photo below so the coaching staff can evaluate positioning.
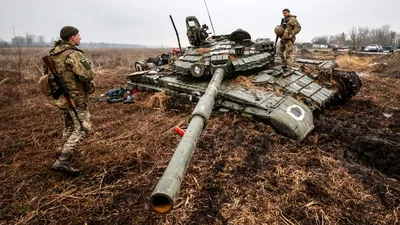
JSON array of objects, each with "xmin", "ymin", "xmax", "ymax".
[{"xmin": 46, "ymin": 26, "xmax": 95, "ymax": 175}]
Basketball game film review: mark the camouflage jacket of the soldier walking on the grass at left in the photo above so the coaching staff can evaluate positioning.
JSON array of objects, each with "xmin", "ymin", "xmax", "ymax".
[{"xmin": 47, "ymin": 42, "xmax": 95, "ymax": 108}]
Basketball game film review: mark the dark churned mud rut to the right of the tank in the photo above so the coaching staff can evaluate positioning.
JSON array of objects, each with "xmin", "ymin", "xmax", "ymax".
[{"xmin": 315, "ymin": 100, "xmax": 400, "ymax": 179}]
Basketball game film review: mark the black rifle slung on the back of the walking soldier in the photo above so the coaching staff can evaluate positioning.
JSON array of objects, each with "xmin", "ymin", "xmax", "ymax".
[{"xmin": 42, "ymin": 55, "xmax": 84, "ymax": 130}]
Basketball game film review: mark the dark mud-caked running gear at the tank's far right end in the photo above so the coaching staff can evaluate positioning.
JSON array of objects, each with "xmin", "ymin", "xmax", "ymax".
[{"xmin": 331, "ymin": 70, "xmax": 362, "ymax": 104}]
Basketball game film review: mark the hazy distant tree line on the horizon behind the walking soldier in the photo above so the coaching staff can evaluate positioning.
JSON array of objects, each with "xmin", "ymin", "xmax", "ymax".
[{"xmin": 0, "ymin": 33, "xmax": 150, "ymax": 48}]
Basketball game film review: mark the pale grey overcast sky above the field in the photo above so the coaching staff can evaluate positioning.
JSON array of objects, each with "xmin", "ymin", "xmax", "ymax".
[{"xmin": 0, "ymin": 0, "xmax": 400, "ymax": 46}]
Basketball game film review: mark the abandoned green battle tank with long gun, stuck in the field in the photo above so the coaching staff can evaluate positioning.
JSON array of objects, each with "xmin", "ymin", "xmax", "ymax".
[{"xmin": 128, "ymin": 16, "xmax": 361, "ymax": 213}]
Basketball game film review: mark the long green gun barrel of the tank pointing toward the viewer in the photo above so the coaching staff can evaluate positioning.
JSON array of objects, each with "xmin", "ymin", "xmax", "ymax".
[{"xmin": 150, "ymin": 68, "xmax": 225, "ymax": 213}]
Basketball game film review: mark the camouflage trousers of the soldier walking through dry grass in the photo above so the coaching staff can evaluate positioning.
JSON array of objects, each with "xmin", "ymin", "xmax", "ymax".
[{"xmin": 59, "ymin": 106, "xmax": 91, "ymax": 161}]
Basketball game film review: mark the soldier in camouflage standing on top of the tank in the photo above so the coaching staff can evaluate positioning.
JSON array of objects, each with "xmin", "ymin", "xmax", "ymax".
[{"xmin": 278, "ymin": 9, "xmax": 301, "ymax": 76}]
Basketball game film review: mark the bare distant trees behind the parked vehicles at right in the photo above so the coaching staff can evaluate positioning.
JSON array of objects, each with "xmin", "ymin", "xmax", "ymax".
[{"xmin": 311, "ymin": 25, "xmax": 400, "ymax": 49}]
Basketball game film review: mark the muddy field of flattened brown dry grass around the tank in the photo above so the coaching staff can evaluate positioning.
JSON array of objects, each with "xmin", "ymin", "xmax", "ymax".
[{"xmin": 0, "ymin": 49, "xmax": 400, "ymax": 224}]
